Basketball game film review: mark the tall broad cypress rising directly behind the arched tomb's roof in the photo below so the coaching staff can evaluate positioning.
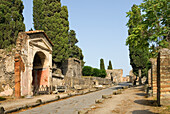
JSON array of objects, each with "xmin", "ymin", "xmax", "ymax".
[{"xmin": 33, "ymin": 0, "xmax": 69, "ymax": 62}]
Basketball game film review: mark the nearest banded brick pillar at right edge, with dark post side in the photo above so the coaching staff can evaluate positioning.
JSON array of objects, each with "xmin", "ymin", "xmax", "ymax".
[{"xmin": 157, "ymin": 49, "xmax": 170, "ymax": 106}]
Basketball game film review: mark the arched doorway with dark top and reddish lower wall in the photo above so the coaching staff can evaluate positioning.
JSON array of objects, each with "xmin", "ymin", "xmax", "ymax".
[{"xmin": 32, "ymin": 51, "xmax": 48, "ymax": 95}]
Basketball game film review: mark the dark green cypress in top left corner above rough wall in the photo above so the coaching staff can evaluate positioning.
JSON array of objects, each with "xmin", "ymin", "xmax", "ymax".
[{"xmin": 0, "ymin": 0, "xmax": 25, "ymax": 49}]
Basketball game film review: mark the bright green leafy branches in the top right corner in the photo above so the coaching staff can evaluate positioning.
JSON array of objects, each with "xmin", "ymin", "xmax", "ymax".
[{"xmin": 140, "ymin": 0, "xmax": 170, "ymax": 50}]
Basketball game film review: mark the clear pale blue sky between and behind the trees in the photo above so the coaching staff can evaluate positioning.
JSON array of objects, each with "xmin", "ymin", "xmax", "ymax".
[{"xmin": 23, "ymin": 0, "xmax": 142, "ymax": 76}]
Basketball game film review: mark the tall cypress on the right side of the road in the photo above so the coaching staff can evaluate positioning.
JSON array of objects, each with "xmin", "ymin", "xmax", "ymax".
[{"xmin": 126, "ymin": 5, "xmax": 149, "ymax": 75}]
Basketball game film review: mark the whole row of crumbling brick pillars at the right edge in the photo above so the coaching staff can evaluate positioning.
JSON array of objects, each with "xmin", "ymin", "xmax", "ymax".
[{"xmin": 148, "ymin": 48, "xmax": 170, "ymax": 105}]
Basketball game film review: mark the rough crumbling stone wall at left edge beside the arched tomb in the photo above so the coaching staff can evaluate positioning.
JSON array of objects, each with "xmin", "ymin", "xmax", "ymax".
[{"xmin": 0, "ymin": 49, "xmax": 15, "ymax": 96}]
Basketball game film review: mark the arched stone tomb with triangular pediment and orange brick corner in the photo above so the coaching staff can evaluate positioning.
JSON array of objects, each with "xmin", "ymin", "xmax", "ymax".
[{"xmin": 15, "ymin": 30, "xmax": 53, "ymax": 98}]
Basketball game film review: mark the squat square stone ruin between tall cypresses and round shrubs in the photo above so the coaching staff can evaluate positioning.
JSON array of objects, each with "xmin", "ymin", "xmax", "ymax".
[{"xmin": 62, "ymin": 58, "xmax": 82, "ymax": 77}]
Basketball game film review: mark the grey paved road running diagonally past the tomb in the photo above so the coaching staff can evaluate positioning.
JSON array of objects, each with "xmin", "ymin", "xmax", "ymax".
[{"xmin": 18, "ymin": 83, "xmax": 127, "ymax": 114}]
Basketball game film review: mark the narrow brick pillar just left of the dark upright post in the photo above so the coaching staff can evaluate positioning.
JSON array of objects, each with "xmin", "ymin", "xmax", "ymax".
[{"xmin": 150, "ymin": 58, "xmax": 157, "ymax": 96}]
